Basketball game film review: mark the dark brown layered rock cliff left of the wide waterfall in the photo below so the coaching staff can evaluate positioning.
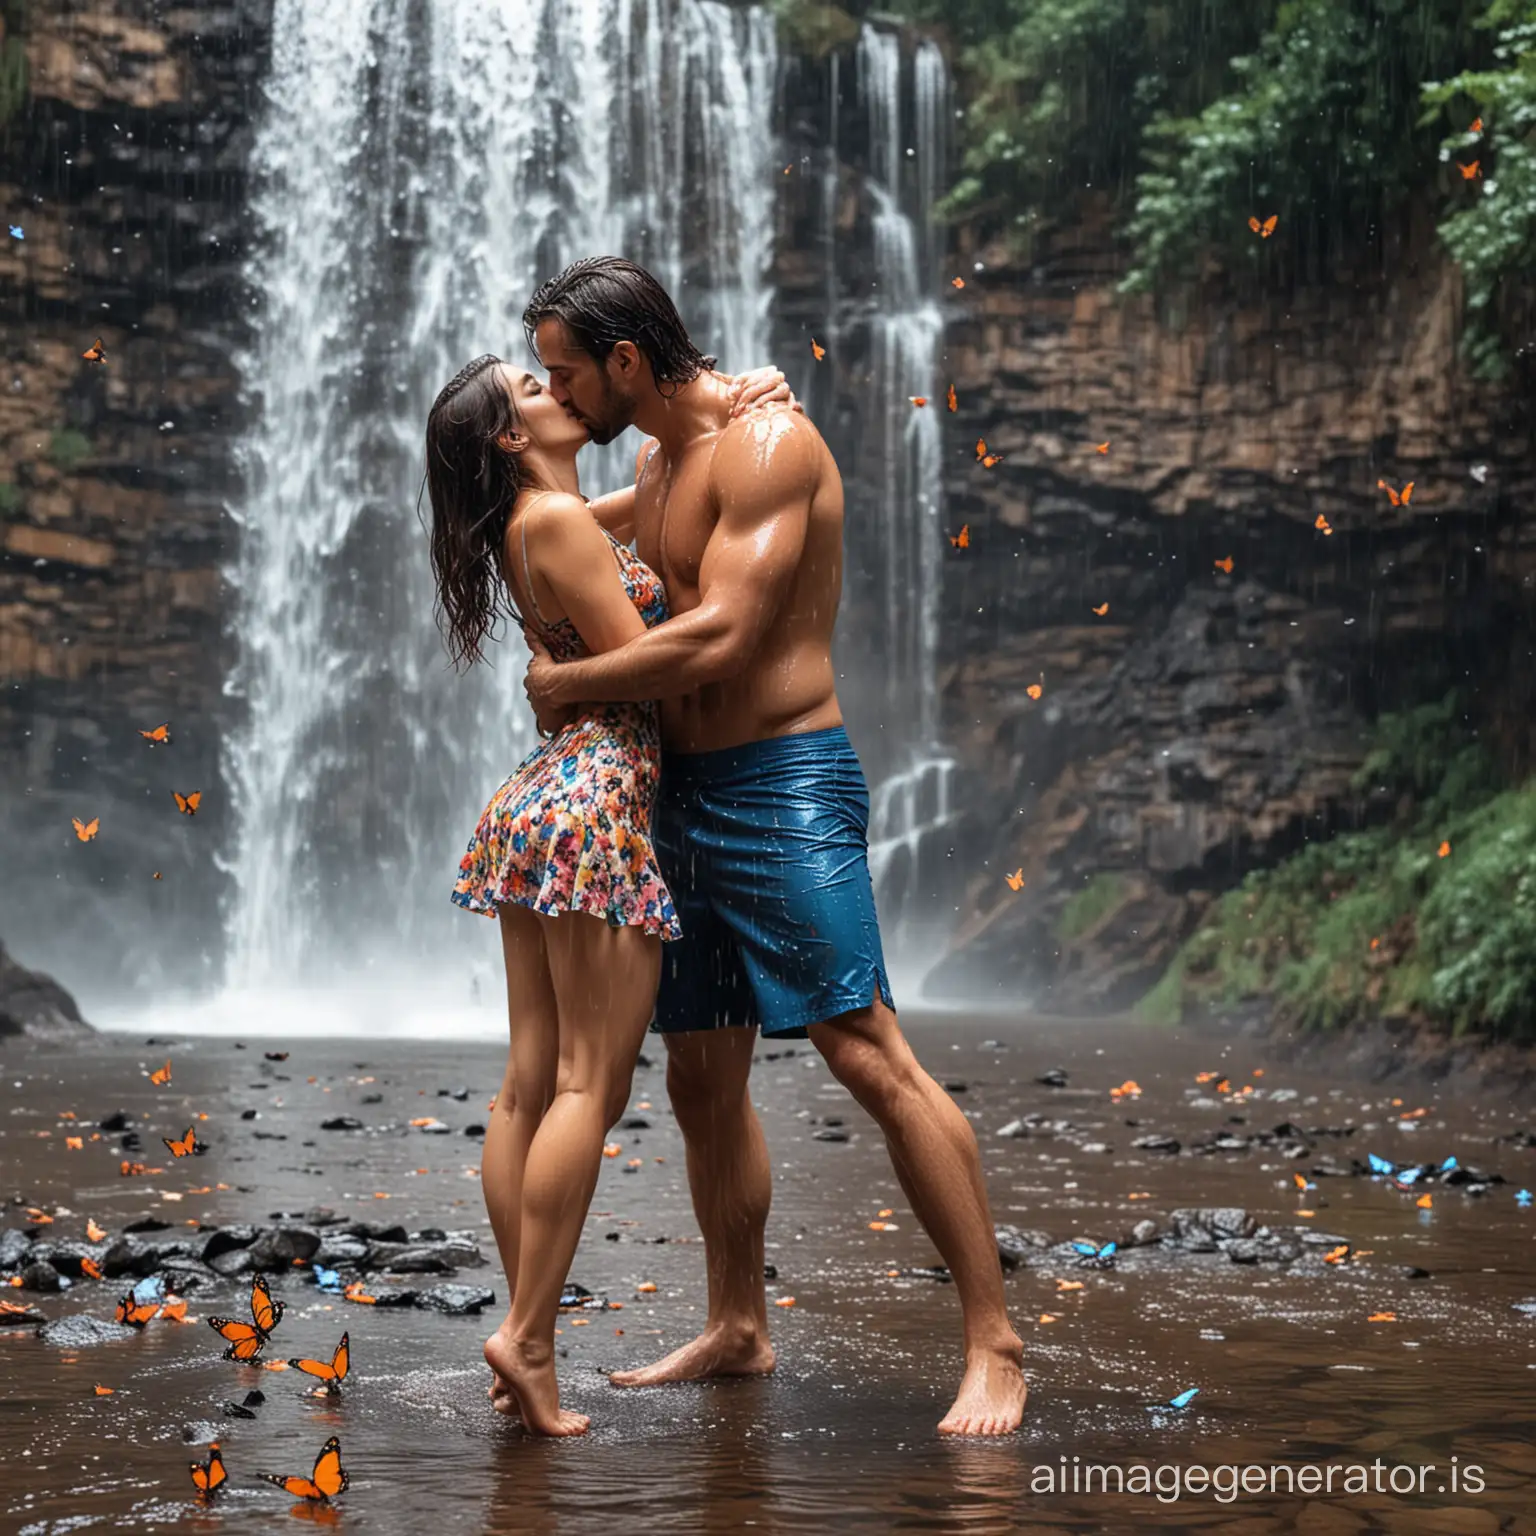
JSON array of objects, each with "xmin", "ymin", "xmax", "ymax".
[{"xmin": 0, "ymin": 0, "xmax": 270, "ymax": 975}]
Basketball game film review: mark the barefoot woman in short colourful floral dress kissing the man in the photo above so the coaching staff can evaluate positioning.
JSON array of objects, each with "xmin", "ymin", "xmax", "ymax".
[{"xmin": 427, "ymin": 355, "xmax": 791, "ymax": 1435}]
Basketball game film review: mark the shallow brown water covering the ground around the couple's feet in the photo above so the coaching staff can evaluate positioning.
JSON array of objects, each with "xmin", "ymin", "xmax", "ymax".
[{"xmin": 0, "ymin": 1018, "xmax": 1536, "ymax": 1536}]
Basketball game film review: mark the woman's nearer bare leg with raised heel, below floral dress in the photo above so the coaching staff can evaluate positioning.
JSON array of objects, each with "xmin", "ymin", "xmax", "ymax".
[{"xmin": 487, "ymin": 912, "xmax": 662, "ymax": 1435}]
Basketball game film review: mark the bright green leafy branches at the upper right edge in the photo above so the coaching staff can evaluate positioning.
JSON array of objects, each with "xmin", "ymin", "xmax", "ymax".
[{"xmin": 1424, "ymin": 0, "xmax": 1536, "ymax": 378}]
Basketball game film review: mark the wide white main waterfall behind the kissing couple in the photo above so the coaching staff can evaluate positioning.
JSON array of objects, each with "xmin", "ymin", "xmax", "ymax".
[{"xmin": 223, "ymin": 0, "xmax": 777, "ymax": 1018}]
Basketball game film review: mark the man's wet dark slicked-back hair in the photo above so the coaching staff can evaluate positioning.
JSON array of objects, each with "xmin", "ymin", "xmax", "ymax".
[{"xmin": 522, "ymin": 257, "xmax": 716, "ymax": 395}]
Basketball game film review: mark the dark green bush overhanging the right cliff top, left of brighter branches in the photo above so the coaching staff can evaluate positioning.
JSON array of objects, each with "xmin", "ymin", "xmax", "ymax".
[{"xmin": 1124, "ymin": 0, "xmax": 1473, "ymax": 292}]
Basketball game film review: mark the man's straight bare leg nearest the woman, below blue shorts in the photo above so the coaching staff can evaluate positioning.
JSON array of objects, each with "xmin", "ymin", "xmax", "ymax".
[{"xmin": 608, "ymin": 1029, "xmax": 774, "ymax": 1387}]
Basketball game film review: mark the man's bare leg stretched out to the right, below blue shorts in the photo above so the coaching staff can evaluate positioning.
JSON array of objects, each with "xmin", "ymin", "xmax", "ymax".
[{"xmin": 809, "ymin": 997, "xmax": 1026, "ymax": 1435}]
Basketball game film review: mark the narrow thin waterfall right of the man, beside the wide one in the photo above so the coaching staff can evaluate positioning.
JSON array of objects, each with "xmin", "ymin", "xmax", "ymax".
[{"xmin": 857, "ymin": 26, "xmax": 957, "ymax": 989}]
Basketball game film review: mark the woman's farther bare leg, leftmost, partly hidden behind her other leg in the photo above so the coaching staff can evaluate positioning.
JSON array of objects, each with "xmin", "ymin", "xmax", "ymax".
[{"xmin": 481, "ymin": 902, "xmax": 559, "ymax": 1413}]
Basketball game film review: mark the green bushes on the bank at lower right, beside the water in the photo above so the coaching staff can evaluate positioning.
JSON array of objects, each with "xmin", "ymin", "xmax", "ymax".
[{"xmin": 1141, "ymin": 700, "xmax": 1536, "ymax": 1038}]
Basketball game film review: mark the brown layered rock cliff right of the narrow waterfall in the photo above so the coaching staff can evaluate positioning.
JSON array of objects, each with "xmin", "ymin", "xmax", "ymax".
[{"xmin": 934, "ymin": 207, "xmax": 1536, "ymax": 1009}]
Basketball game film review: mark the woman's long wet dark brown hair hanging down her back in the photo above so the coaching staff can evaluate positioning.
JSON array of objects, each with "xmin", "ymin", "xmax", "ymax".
[{"xmin": 427, "ymin": 352, "xmax": 527, "ymax": 670}]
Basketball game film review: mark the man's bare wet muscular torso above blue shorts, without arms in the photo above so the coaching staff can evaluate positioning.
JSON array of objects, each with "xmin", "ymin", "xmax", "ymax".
[{"xmin": 634, "ymin": 402, "xmax": 843, "ymax": 753}]
